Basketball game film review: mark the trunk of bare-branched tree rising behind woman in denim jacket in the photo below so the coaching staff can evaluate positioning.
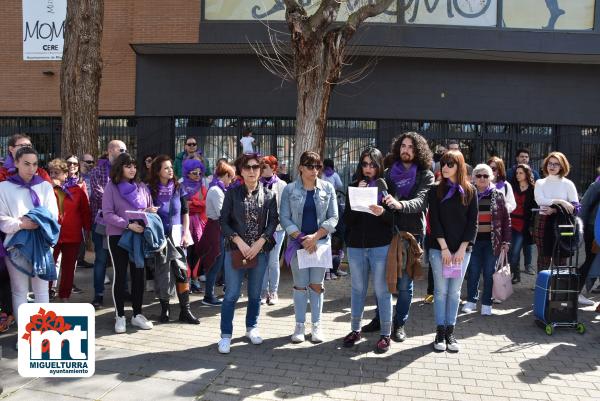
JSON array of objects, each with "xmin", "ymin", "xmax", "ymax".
[{"xmin": 294, "ymin": 31, "xmax": 343, "ymax": 167}]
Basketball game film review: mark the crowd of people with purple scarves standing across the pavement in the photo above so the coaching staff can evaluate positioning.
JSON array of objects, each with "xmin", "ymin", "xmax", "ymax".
[{"xmin": 0, "ymin": 131, "xmax": 600, "ymax": 353}]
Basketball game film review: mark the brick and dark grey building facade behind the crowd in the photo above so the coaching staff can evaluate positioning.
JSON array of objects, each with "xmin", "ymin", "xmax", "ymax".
[{"xmin": 0, "ymin": 0, "xmax": 600, "ymax": 190}]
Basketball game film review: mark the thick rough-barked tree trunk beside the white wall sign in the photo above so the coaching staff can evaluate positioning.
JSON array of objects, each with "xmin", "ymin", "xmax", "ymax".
[{"xmin": 60, "ymin": 0, "xmax": 104, "ymax": 156}]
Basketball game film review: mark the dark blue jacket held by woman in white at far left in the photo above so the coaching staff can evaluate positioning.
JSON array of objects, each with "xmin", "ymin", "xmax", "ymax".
[{"xmin": 6, "ymin": 206, "xmax": 60, "ymax": 281}]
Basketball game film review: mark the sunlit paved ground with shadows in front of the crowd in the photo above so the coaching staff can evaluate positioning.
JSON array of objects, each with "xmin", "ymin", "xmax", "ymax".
[{"xmin": 0, "ymin": 255, "xmax": 600, "ymax": 401}]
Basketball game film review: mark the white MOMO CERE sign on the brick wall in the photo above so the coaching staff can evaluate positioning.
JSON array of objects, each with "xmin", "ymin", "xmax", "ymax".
[{"xmin": 23, "ymin": 0, "xmax": 67, "ymax": 60}]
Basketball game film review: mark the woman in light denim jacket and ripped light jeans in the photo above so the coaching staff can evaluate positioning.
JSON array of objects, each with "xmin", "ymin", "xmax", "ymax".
[{"xmin": 280, "ymin": 151, "xmax": 338, "ymax": 343}]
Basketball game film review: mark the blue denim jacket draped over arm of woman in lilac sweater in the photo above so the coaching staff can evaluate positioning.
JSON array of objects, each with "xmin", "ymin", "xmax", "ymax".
[{"xmin": 118, "ymin": 213, "xmax": 167, "ymax": 268}]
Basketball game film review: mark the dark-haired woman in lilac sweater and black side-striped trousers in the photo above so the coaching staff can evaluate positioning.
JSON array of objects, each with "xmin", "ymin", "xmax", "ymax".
[{"xmin": 102, "ymin": 153, "xmax": 157, "ymax": 334}]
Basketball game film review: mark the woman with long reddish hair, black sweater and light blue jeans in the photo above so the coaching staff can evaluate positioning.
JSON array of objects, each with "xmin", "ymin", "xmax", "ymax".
[{"xmin": 428, "ymin": 150, "xmax": 477, "ymax": 352}]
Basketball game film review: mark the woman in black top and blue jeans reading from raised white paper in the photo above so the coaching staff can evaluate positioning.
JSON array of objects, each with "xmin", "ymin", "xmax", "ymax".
[{"xmin": 344, "ymin": 148, "xmax": 394, "ymax": 353}]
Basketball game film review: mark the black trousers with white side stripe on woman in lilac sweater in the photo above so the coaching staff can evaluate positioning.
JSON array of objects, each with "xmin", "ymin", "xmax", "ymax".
[{"xmin": 108, "ymin": 235, "xmax": 146, "ymax": 317}]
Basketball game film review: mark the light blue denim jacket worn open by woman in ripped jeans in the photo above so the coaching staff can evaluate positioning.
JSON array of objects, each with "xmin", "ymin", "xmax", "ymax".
[{"xmin": 279, "ymin": 178, "xmax": 338, "ymax": 237}]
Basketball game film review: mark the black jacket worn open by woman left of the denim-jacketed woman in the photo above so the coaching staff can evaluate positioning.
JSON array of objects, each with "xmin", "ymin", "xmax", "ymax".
[{"xmin": 219, "ymin": 185, "xmax": 279, "ymax": 252}]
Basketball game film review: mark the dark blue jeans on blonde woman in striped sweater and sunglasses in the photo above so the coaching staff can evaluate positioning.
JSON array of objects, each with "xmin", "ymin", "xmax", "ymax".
[{"xmin": 467, "ymin": 240, "xmax": 497, "ymax": 306}]
